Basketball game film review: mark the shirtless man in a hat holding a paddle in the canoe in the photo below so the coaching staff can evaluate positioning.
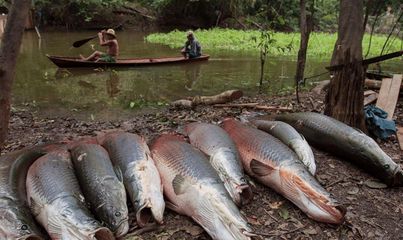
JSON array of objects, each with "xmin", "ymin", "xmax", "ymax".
[{"xmin": 80, "ymin": 29, "xmax": 119, "ymax": 63}]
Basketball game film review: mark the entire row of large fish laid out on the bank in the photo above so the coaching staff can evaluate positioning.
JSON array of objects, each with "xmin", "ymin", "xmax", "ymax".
[{"xmin": 0, "ymin": 113, "xmax": 403, "ymax": 239}]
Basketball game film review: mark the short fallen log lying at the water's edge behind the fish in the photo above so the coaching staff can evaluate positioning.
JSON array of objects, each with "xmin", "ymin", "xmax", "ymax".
[{"xmin": 171, "ymin": 90, "xmax": 243, "ymax": 108}]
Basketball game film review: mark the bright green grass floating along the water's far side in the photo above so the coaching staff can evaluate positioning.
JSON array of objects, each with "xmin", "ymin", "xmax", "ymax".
[{"xmin": 146, "ymin": 28, "xmax": 402, "ymax": 59}]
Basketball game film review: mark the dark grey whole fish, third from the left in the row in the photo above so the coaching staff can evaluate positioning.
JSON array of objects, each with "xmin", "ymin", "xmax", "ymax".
[{"xmin": 71, "ymin": 143, "xmax": 129, "ymax": 237}]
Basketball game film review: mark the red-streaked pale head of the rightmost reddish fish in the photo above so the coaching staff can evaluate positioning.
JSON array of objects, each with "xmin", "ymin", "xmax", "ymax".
[{"xmin": 280, "ymin": 169, "xmax": 346, "ymax": 224}]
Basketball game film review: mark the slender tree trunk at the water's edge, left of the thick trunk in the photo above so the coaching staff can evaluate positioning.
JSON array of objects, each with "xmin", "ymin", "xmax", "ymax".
[{"xmin": 295, "ymin": 0, "xmax": 312, "ymax": 103}]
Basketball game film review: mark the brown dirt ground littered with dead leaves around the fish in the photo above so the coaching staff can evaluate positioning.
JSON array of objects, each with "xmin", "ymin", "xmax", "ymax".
[{"xmin": 5, "ymin": 91, "xmax": 403, "ymax": 240}]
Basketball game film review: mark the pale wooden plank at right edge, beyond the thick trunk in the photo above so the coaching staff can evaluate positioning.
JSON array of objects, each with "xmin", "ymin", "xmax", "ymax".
[{"xmin": 376, "ymin": 74, "xmax": 402, "ymax": 120}]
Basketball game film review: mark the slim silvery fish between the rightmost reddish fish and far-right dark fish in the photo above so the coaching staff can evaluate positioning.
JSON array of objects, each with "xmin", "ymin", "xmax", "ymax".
[{"xmin": 252, "ymin": 120, "xmax": 316, "ymax": 175}]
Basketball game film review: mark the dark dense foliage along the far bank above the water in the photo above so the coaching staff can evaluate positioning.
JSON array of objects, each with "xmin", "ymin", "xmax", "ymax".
[{"xmin": 0, "ymin": 0, "xmax": 401, "ymax": 32}]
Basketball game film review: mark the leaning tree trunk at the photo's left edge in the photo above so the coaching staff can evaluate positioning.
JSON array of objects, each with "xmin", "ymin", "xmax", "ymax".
[{"xmin": 0, "ymin": 0, "xmax": 31, "ymax": 150}]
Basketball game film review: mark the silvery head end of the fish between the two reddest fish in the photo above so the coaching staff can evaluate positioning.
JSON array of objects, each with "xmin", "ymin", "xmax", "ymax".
[{"xmin": 210, "ymin": 148, "xmax": 253, "ymax": 206}]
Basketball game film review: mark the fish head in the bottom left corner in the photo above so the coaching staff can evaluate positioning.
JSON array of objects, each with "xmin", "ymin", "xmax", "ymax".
[{"xmin": 0, "ymin": 207, "xmax": 43, "ymax": 240}]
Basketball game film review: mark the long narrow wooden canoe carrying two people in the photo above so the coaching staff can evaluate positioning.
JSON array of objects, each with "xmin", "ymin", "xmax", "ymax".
[{"xmin": 46, "ymin": 55, "xmax": 210, "ymax": 68}]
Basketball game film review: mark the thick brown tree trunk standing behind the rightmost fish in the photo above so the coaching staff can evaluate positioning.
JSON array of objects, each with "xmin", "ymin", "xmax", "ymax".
[{"xmin": 325, "ymin": 0, "xmax": 366, "ymax": 131}]
